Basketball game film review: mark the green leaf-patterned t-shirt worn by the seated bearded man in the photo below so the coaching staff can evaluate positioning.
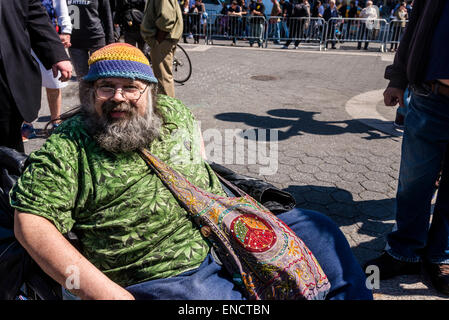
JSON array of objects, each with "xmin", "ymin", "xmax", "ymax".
[{"xmin": 11, "ymin": 96, "xmax": 225, "ymax": 286}]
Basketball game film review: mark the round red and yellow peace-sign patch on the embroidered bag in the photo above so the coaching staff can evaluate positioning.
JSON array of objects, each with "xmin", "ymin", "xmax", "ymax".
[{"xmin": 231, "ymin": 214, "xmax": 276, "ymax": 252}]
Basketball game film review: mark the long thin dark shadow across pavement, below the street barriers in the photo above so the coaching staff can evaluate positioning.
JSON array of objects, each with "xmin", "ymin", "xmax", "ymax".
[{"xmin": 215, "ymin": 109, "xmax": 396, "ymax": 141}]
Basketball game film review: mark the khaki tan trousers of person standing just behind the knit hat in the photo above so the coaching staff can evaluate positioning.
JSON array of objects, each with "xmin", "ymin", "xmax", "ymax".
[{"xmin": 149, "ymin": 40, "xmax": 177, "ymax": 97}]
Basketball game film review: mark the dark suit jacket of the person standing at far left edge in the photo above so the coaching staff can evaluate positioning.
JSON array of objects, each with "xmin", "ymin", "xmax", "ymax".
[{"xmin": 0, "ymin": 0, "xmax": 70, "ymax": 122}]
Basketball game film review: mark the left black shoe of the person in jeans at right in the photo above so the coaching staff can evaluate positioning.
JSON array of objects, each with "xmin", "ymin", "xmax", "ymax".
[{"xmin": 363, "ymin": 252, "xmax": 421, "ymax": 280}]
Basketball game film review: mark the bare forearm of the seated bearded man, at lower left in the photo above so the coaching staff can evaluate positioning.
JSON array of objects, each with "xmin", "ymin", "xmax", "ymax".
[{"xmin": 14, "ymin": 210, "xmax": 134, "ymax": 300}]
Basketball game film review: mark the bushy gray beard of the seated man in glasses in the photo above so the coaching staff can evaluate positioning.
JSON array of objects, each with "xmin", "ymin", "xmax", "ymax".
[{"xmin": 81, "ymin": 100, "xmax": 162, "ymax": 153}]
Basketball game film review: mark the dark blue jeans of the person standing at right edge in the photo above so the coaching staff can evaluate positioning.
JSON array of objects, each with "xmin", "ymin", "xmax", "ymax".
[{"xmin": 387, "ymin": 91, "xmax": 449, "ymax": 263}]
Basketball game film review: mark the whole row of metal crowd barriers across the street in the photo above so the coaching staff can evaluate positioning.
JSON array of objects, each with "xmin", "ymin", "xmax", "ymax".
[{"xmin": 189, "ymin": 13, "xmax": 408, "ymax": 52}]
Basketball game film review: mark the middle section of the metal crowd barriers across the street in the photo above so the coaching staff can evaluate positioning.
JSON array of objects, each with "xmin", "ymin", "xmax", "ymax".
[{"xmin": 265, "ymin": 17, "xmax": 326, "ymax": 47}]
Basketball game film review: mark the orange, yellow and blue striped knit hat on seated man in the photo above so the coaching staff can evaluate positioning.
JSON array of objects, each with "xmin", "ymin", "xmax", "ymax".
[{"xmin": 83, "ymin": 43, "xmax": 157, "ymax": 83}]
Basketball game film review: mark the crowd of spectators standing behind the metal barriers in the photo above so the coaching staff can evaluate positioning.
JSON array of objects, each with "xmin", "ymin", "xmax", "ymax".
[{"xmin": 178, "ymin": 0, "xmax": 412, "ymax": 51}]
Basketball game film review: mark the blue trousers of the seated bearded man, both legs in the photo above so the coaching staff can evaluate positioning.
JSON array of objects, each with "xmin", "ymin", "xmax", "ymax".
[{"xmin": 126, "ymin": 209, "xmax": 372, "ymax": 300}]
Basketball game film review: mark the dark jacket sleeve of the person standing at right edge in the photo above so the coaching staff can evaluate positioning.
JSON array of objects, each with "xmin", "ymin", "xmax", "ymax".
[{"xmin": 385, "ymin": 0, "xmax": 446, "ymax": 89}]
